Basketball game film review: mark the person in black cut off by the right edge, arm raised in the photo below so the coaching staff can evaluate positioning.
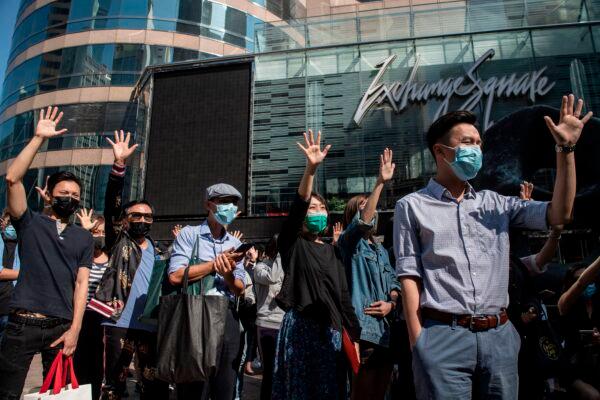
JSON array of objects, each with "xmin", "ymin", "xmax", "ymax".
[{"xmin": 558, "ymin": 257, "xmax": 600, "ymax": 399}]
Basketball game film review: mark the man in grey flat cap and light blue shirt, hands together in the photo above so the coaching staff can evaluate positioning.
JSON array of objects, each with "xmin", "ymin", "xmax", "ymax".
[{"xmin": 169, "ymin": 183, "xmax": 246, "ymax": 400}]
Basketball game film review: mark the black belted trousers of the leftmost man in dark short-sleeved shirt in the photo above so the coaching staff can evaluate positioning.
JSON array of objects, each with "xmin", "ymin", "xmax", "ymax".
[{"xmin": 0, "ymin": 316, "xmax": 71, "ymax": 400}]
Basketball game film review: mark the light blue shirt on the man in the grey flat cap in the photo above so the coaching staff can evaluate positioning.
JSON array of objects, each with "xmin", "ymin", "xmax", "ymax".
[{"xmin": 169, "ymin": 221, "xmax": 249, "ymax": 299}]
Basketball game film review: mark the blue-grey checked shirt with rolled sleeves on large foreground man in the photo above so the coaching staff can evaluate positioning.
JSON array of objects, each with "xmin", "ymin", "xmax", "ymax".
[{"xmin": 394, "ymin": 179, "xmax": 548, "ymax": 314}]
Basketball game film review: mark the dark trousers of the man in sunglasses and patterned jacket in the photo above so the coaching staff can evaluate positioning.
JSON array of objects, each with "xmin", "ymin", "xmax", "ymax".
[{"xmin": 102, "ymin": 326, "xmax": 169, "ymax": 400}]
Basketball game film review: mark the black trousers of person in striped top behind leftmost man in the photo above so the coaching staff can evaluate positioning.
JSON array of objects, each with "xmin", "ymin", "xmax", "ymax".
[{"xmin": 73, "ymin": 310, "xmax": 104, "ymax": 400}]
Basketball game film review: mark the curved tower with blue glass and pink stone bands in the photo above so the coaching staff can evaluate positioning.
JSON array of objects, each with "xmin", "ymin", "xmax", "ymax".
[{"xmin": 0, "ymin": 0, "xmax": 303, "ymax": 210}]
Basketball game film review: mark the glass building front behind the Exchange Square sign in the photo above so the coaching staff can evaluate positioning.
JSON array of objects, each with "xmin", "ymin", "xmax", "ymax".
[{"xmin": 251, "ymin": 0, "xmax": 600, "ymax": 222}]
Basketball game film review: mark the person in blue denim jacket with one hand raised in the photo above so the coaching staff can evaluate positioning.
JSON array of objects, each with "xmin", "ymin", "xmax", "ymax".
[{"xmin": 337, "ymin": 149, "xmax": 400, "ymax": 399}]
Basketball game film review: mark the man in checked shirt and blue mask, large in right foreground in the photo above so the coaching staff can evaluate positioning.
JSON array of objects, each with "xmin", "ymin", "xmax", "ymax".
[{"xmin": 394, "ymin": 95, "xmax": 591, "ymax": 399}]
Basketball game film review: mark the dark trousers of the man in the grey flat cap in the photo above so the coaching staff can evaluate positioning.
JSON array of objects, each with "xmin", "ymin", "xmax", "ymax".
[{"xmin": 177, "ymin": 309, "xmax": 240, "ymax": 400}]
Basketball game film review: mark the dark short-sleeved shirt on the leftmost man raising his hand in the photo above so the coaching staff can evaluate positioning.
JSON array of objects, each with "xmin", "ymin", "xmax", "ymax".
[{"xmin": 10, "ymin": 209, "xmax": 94, "ymax": 320}]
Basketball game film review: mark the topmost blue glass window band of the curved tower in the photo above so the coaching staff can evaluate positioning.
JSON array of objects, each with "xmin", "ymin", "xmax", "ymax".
[{"xmin": 9, "ymin": 0, "xmax": 268, "ymax": 62}]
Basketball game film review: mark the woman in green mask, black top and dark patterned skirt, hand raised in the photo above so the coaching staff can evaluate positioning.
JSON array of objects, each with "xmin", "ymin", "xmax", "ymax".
[{"xmin": 272, "ymin": 131, "xmax": 360, "ymax": 400}]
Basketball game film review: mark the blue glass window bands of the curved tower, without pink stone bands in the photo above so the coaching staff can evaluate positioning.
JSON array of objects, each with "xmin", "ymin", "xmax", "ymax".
[{"xmin": 0, "ymin": 0, "xmax": 282, "ymax": 211}]
